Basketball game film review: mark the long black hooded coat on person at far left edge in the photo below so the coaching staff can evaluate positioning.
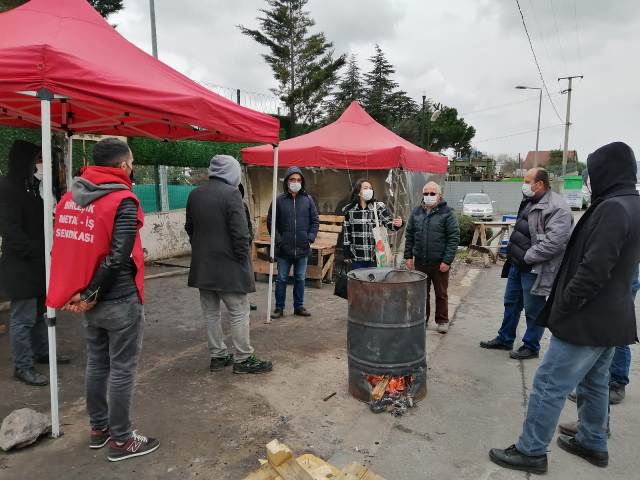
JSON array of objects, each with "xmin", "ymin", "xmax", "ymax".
[{"xmin": 0, "ymin": 140, "xmax": 45, "ymax": 300}]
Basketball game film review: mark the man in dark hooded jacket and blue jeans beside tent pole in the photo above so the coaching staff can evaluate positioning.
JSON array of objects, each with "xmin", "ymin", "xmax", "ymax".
[{"xmin": 267, "ymin": 167, "xmax": 320, "ymax": 318}]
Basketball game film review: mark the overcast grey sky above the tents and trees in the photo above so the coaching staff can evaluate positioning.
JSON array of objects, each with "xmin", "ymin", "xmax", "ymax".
[{"xmin": 109, "ymin": 0, "xmax": 640, "ymax": 160}]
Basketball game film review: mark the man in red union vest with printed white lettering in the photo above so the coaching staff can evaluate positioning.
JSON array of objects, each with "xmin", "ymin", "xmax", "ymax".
[{"xmin": 47, "ymin": 138, "xmax": 159, "ymax": 462}]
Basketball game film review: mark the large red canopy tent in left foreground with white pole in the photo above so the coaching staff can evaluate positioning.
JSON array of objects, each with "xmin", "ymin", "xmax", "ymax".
[{"xmin": 0, "ymin": 0, "xmax": 279, "ymax": 437}]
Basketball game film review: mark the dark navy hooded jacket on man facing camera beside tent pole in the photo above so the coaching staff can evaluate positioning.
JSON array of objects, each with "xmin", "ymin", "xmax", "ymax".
[{"xmin": 267, "ymin": 167, "xmax": 320, "ymax": 258}]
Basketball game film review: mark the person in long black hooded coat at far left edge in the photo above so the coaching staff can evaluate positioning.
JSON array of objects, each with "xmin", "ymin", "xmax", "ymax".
[{"xmin": 0, "ymin": 140, "xmax": 69, "ymax": 386}]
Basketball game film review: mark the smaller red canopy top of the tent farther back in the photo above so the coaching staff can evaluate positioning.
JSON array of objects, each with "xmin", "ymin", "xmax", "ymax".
[{"xmin": 242, "ymin": 102, "xmax": 447, "ymax": 173}]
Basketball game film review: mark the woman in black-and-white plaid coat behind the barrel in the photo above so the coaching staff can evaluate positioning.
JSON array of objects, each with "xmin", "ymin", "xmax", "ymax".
[{"xmin": 342, "ymin": 180, "xmax": 402, "ymax": 269}]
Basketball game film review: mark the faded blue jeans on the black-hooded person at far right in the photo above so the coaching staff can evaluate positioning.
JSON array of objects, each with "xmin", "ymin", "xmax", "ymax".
[{"xmin": 516, "ymin": 337, "xmax": 614, "ymax": 456}]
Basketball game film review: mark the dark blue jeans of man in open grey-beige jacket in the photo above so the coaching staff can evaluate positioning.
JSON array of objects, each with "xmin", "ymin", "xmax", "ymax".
[{"xmin": 497, "ymin": 265, "xmax": 546, "ymax": 352}]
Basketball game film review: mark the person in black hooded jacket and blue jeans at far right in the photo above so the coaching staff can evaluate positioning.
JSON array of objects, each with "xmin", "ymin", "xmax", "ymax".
[{"xmin": 489, "ymin": 142, "xmax": 640, "ymax": 473}]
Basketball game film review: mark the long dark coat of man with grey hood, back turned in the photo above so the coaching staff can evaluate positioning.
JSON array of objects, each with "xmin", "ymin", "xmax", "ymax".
[{"xmin": 185, "ymin": 177, "xmax": 256, "ymax": 293}]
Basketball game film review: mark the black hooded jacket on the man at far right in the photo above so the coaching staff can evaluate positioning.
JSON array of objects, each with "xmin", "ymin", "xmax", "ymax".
[{"xmin": 538, "ymin": 142, "xmax": 640, "ymax": 346}]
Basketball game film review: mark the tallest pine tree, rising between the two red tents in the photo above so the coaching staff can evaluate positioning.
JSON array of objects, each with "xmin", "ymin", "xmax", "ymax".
[{"xmin": 239, "ymin": 0, "xmax": 345, "ymax": 136}]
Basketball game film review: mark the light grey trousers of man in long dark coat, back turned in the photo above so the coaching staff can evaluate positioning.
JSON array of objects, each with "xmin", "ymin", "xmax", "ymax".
[{"xmin": 200, "ymin": 290, "xmax": 253, "ymax": 362}]
